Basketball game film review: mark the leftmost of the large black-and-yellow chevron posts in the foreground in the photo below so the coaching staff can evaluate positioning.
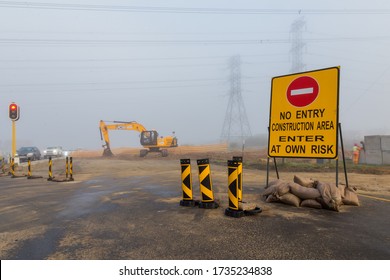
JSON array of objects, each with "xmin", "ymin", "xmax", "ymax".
[{"xmin": 180, "ymin": 159, "xmax": 199, "ymax": 207}]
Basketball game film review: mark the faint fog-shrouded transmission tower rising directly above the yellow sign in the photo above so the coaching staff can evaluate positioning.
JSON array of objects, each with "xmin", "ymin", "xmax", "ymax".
[{"xmin": 290, "ymin": 17, "xmax": 306, "ymax": 73}]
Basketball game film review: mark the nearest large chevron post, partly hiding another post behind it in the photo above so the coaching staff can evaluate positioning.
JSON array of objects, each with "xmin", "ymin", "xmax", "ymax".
[{"xmin": 225, "ymin": 160, "xmax": 245, "ymax": 218}]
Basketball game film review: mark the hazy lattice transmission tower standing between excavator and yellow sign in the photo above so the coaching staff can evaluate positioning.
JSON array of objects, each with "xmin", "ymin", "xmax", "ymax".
[{"xmin": 221, "ymin": 55, "xmax": 252, "ymax": 143}]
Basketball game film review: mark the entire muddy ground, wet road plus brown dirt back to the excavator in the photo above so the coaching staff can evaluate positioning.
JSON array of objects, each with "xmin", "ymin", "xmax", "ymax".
[{"xmin": 0, "ymin": 145, "xmax": 390, "ymax": 260}]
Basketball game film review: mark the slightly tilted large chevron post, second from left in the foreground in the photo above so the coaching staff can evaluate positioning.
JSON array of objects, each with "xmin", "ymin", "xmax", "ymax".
[{"xmin": 197, "ymin": 159, "xmax": 219, "ymax": 209}]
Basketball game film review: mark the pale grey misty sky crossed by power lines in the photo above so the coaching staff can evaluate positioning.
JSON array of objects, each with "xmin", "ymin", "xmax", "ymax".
[{"xmin": 0, "ymin": 0, "xmax": 390, "ymax": 153}]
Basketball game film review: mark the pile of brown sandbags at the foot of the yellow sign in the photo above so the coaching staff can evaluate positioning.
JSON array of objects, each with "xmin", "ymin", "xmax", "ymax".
[{"xmin": 262, "ymin": 176, "xmax": 360, "ymax": 211}]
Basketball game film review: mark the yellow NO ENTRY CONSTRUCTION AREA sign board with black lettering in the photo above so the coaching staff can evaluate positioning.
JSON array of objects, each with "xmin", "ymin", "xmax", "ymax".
[{"xmin": 268, "ymin": 67, "xmax": 340, "ymax": 158}]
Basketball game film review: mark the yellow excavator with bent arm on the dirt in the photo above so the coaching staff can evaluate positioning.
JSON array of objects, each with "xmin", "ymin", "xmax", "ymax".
[{"xmin": 99, "ymin": 120, "xmax": 177, "ymax": 157}]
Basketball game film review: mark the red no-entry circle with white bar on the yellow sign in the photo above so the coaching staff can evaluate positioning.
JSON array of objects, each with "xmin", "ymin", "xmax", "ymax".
[{"xmin": 287, "ymin": 76, "xmax": 319, "ymax": 107}]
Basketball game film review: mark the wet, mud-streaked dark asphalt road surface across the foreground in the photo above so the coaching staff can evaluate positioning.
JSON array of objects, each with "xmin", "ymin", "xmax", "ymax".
[{"xmin": 0, "ymin": 160, "xmax": 390, "ymax": 260}]
